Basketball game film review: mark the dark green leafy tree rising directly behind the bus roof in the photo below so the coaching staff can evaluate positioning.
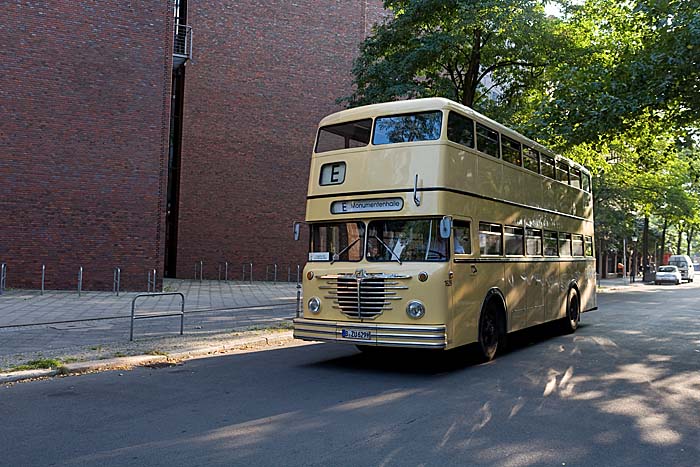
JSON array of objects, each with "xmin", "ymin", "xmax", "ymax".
[{"xmin": 341, "ymin": 0, "xmax": 564, "ymax": 113}]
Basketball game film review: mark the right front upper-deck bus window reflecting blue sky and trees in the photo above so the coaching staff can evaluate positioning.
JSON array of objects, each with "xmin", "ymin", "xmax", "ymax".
[{"xmin": 372, "ymin": 110, "xmax": 442, "ymax": 145}]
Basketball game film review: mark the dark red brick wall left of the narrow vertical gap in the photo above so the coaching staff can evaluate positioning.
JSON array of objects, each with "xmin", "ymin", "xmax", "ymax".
[{"xmin": 0, "ymin": 0, "xmax": 172, "ymax": 290}]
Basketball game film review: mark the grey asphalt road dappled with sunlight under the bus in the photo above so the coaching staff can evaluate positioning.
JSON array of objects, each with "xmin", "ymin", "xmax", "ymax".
[{"xmin": 0, "ymin": 283, "xmax": 700, "ymax": 466}]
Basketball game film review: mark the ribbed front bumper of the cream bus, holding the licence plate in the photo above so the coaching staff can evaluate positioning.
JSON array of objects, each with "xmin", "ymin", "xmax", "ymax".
[{"xmin": 294, "ymin": 318, "xmax": 447, "ymax": 349}]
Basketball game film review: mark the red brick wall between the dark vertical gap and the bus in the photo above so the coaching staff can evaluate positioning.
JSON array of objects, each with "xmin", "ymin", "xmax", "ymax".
[{"xmin": 177, "ymin": 0, "xmax": 384, "ymax": 279}]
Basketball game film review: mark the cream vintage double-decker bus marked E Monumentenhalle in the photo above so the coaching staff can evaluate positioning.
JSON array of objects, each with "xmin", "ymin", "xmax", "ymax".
[{"xmin": 294, "ymin": 98, "xmax": 596, "ymax": 360}]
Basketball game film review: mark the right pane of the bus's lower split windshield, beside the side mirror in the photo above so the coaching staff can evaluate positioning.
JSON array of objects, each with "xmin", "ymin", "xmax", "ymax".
[{"xmin": 367, "ymin": 219, "xmax": 448, "ymax": 263}]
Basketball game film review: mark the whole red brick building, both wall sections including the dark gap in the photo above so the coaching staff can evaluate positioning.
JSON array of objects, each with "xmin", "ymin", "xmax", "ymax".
[{"xmin": 0, "ymin": 0, "xmax": 384, "ymax": 290}]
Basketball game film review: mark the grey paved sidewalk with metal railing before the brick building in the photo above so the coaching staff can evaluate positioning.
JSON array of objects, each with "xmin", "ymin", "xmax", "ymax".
[{"xmin": 0, "ymin": 279, "xmax": 297, "ymax": 370}]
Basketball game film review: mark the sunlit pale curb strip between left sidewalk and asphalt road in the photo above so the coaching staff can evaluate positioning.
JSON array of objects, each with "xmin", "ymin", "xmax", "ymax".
[{"xmin": 0, "ymin": 331, "xmax": 294, "ymax": 384}]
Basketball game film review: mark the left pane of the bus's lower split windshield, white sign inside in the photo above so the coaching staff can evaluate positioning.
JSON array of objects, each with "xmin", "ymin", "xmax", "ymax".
[{"xmin": 309, "ymin": 222, "xmax": 365, "ymax": 261}]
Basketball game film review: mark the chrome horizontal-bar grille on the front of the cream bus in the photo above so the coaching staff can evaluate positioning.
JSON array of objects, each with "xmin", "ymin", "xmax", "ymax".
[{"xmin": 320, "ymin": 270, "xmax": 411, "ymax": 319}]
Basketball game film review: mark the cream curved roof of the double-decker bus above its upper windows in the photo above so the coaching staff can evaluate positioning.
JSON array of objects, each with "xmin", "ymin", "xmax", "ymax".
[{"xmin": 319, "ymin": 97, "xmax": 590, "ymax": 177}]
